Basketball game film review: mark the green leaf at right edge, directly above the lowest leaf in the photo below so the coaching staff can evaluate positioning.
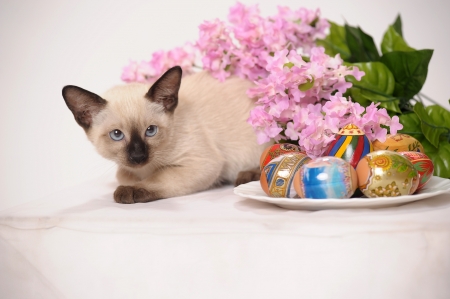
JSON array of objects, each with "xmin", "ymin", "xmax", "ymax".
[{"xmin": 414, "ymin": 103, "xmax": 450, "ymax": 147}]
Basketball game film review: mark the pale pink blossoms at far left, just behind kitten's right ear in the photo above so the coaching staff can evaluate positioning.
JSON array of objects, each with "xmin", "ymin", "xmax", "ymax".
[{"xmin": 121, "ymin": 43, "xmax": 196, "ymax": 83}]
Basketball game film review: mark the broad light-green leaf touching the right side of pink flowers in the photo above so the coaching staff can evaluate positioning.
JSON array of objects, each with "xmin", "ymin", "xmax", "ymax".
[{"xmin": 345, "ymin": 62, "xmax": 401, "ymax": 113}]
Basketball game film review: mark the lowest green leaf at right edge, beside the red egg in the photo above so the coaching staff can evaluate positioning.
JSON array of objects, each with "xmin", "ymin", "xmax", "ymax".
[{"xmin": 419, "ymin": 139, "xmax": 450, "ymax": 179}]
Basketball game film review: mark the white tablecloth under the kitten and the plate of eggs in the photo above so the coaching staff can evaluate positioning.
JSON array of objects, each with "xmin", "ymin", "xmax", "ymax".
[{"xmin": 0, "ymin": 177, "xmax": 450, "ymax": 299}]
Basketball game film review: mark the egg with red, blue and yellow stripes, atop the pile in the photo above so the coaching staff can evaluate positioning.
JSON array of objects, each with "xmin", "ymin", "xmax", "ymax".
[{"xmin": 324, "ymin": 124, "xmax": 373, "ymax": 168}]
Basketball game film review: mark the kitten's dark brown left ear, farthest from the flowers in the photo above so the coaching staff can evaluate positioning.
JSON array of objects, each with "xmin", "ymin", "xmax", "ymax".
[{"xmin": 62, "ymin": 85, "xmax": 107, "ymax": 130}]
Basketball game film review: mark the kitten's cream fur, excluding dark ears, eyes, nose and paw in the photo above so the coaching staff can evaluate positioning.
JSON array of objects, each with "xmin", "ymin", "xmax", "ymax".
[{"xmin": 87, "ymin": 72, "xmax": 267, "ymax": 200}]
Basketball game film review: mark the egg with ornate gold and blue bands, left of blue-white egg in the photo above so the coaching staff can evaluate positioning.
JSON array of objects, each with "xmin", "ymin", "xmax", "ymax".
[{"xmin": 260, "ymin": 153, "xmax": 311, "ymax": 198}]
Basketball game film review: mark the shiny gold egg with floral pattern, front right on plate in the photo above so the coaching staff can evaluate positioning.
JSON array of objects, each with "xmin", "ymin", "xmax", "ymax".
[{"xmin": 356, "ymin": 150, "xmax": 419, "ymax": 197}]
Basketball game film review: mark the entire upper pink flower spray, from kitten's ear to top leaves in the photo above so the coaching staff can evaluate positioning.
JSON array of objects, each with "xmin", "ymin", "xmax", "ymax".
[{"xmin": 121, "ymin": 3, "xmax": 329, "ymax": 83}]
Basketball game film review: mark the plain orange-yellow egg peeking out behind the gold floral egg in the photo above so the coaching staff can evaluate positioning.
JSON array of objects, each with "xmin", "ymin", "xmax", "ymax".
[{"xmin": 373, "ymin": 134, "xmax": 425, "ymax": 153}]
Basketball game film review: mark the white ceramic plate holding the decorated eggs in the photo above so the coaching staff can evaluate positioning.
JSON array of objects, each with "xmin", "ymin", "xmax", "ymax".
[{"xmin": 234, "ymin": 176, "xmax": 450, "ymax": 210}]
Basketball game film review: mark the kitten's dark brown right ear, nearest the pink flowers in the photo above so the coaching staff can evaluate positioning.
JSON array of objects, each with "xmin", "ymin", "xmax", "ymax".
[{"xmin": 145, "ymin": 66, "xmax": 182, "ymax": 112}]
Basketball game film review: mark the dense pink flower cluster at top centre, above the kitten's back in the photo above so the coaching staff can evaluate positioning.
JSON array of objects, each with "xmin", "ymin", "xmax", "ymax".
[{"xmin": 196, "ymin": 3, "xmax": 329, "ymax": 81}]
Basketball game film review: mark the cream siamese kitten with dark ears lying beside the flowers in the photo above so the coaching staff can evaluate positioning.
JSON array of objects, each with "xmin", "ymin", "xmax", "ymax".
[{"xmin": 62, "ymin": 66, "xmax": 267, "ymax": 203}]
